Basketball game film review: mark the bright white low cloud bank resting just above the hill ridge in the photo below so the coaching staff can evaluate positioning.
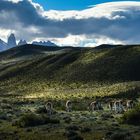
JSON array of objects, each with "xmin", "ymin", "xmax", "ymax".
[{"xmin": 43, "ymin": 35, "xmax": 125, "ymax": 47}]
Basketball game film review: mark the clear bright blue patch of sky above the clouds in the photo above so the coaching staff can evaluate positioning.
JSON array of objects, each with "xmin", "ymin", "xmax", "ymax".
[{"xmin": 33, "ymin": 0, "xmax": 140, "ymax": 10}]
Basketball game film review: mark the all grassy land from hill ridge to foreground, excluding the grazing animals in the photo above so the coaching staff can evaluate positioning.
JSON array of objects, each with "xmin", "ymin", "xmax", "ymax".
[{"xmin": 0, "ymin": 45, "xmax": 140, "ymax": 140}]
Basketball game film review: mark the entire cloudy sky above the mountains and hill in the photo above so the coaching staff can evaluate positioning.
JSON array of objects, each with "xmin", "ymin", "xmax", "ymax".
[{"xmin": 0, "ymin": 0, "xmax": 140, "ymax": 47}]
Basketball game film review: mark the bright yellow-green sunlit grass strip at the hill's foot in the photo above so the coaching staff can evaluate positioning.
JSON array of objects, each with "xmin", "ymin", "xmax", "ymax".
[{"xmin": 18, "ymin": 82, "xmax": 140, "ymax": 100}]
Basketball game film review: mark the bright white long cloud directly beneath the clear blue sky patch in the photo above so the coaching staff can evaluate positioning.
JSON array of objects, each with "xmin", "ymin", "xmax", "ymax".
[{"xmin": 43, "ymin": 1, "xmax": 140, "ymax": 21}]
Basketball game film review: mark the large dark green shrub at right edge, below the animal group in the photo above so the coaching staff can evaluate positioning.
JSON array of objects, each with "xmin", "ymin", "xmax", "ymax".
[{"xmin": 121, "ymin": 105, "xmax": 140, "ymax": 125}]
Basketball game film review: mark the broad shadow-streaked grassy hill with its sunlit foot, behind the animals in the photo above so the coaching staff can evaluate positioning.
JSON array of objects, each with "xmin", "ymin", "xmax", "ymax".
[{"xmin": 0, "ymin": 45, "xmax": 140, "ymax": 98}]
